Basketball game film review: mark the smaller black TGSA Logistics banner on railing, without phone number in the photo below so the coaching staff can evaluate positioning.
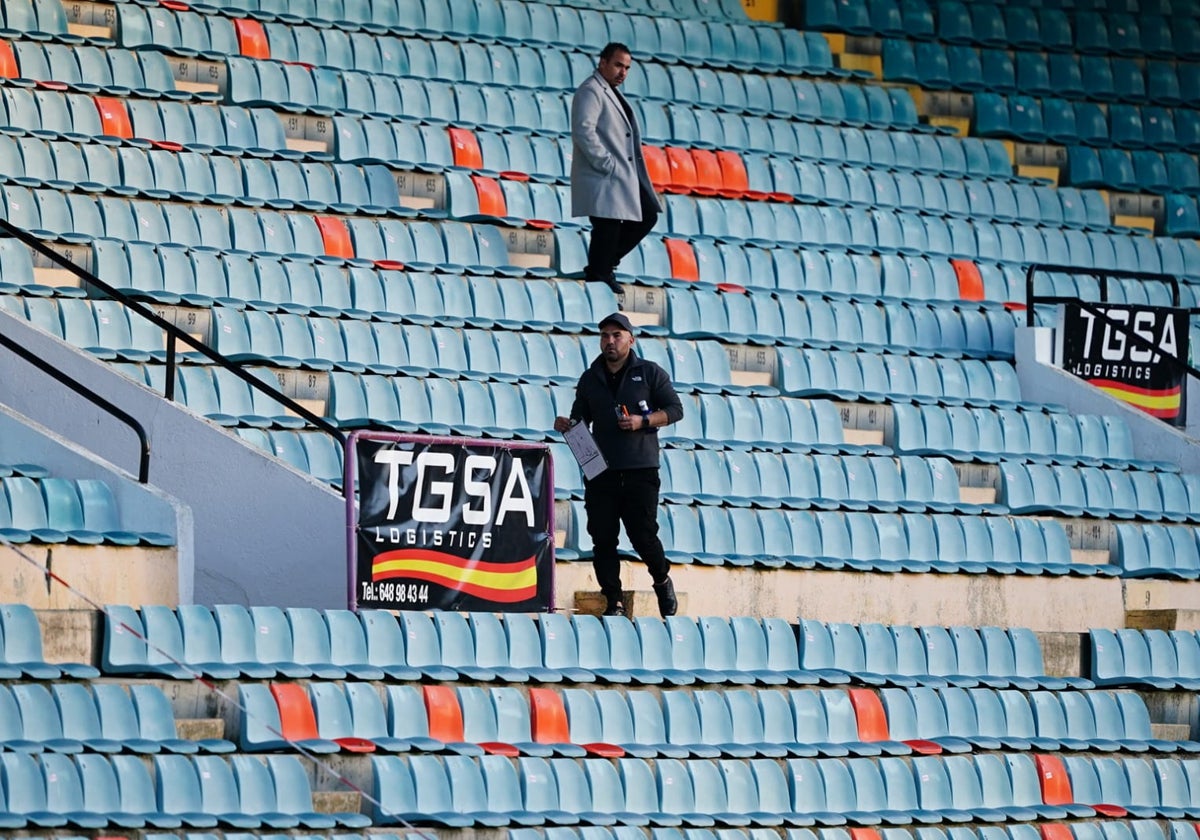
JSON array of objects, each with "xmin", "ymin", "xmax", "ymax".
[{"xmin": 1058, "ymin": 304, "xmax": 1188, "ymax": 426}]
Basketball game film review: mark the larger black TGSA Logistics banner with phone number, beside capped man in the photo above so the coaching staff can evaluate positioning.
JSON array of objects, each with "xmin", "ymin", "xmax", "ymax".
[{"xmin": 350, "ymin": 436, "xmax": 554, "ymax": 612}]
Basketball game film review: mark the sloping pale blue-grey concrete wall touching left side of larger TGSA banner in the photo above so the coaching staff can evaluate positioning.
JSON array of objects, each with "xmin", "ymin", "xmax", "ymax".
[{"xmin": 0, "ymin": 312, "xmax": 347, "ymax": 607}]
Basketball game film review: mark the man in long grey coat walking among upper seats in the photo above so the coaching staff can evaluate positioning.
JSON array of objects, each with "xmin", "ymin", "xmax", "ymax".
[{"xmin": 571, "ymin": 43, "xmax": 662, "ymax": 294}]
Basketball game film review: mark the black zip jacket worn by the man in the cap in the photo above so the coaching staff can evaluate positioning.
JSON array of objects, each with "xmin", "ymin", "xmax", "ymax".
[{"xmin": 571, "ymin": 353, "xmax": 683, "ymax": 469}]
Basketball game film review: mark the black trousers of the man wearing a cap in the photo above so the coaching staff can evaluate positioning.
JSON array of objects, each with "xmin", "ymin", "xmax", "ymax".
[{"xmin": 583, "ymin": 467, "xmax": 668, "ymax": 604}]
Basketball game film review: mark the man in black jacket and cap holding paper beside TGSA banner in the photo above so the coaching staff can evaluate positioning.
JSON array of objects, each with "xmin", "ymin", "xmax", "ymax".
[{"xmin": 554, "ymin": 312, "xmax": 683, "ymax": 617}]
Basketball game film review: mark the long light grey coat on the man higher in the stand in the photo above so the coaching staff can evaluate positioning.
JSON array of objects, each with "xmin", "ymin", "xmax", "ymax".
[{"xmin": 571, "ymin": 72, "xmax": 662, "ymax": 222}]
